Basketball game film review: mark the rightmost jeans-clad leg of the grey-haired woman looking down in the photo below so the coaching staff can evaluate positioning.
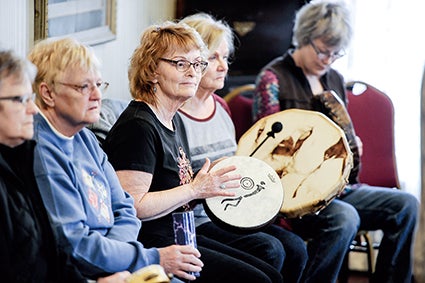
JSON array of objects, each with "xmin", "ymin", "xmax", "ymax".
[{"xmin": 342, "ymin": 185, "xmax": 419, "ymax": 283}]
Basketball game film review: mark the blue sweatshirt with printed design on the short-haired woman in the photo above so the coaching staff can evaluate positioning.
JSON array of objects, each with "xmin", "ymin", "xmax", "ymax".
[{"xmin": 34, "ymin": 114, "xmax": 159, "ymax": 278}]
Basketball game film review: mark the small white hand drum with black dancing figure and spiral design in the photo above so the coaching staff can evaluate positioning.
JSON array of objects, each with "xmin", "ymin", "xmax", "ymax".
[{"xmin": 204, "ymin": 156, "xmax": 284, "ymax": 232}]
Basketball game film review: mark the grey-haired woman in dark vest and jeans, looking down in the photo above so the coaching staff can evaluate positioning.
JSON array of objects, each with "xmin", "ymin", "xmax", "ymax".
[{"xmin": 253, "ymin": 1, "xmax": 418, "ymax": 282}]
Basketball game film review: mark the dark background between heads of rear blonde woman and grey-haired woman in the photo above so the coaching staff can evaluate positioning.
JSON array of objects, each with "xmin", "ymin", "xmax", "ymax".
[{"xmin": 176, "ymin": 0, "xmax": 308, "ymax": 95}]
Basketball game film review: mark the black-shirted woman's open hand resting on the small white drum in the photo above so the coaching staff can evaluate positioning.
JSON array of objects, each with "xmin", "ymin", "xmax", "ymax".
[{"xmin": 191, "ymin": 158, "xmax": 241, "ymax": 199}]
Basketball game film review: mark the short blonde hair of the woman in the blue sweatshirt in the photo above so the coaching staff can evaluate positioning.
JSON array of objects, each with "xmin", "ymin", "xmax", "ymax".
[{"xmin": 28, "ymin": 38, "xmax": 100, "ymax": 106}]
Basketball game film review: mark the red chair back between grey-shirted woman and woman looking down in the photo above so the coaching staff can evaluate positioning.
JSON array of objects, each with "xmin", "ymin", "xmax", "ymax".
[{"xmin": 224, "ymin": 84, "xmax": 255, "ymax": 141}]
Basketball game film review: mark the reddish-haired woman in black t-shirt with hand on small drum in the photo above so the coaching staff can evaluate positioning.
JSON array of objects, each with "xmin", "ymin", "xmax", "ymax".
[{"xmin": 104, "ymin": 22, "xmax": 282, "ymax": 282}]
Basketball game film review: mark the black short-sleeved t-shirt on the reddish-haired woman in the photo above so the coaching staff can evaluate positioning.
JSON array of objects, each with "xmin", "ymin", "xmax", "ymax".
[{"xmin": 104, "ymin": 101, "xmax": 193, "ymax": 247}]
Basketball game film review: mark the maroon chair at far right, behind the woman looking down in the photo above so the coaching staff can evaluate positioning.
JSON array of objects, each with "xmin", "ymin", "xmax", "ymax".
[{"xmin": 339, "ymin": 81, "xmax": 400, "ymax": 283}]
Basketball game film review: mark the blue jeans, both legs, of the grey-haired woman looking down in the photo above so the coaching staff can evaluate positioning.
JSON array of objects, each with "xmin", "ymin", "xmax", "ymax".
[{"xmin": 291, "ymin": 184, "xmax": 419, "ymax": 283}]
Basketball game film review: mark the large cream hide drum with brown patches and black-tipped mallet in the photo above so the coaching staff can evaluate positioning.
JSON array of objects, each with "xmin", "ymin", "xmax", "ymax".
[{"xmin": 236, "ymin": 109, "xmax": 353, "ymax": 218}]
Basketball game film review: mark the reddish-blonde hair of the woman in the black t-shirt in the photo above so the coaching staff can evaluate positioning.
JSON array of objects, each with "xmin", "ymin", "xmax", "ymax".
[{"xmin": 128, "ymin": 21, "xmax": 207, "ymax": 105}]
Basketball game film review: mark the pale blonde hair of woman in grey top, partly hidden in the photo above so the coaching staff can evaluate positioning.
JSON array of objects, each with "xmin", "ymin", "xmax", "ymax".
[{"xmin": 181, "ymin": 13, "xmax": 235, "ymax": 54}]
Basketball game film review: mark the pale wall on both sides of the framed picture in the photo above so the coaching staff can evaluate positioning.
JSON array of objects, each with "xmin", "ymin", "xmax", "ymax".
[{"xmin": 0, "ymin": 0, "xmax": 176, "ymax": 99}]
